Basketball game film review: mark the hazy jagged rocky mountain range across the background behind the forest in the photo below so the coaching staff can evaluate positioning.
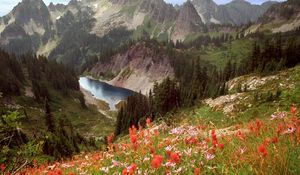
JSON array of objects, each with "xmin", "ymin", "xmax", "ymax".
[{"xmin": 0, "ymin": 0, "xmax": 278, "ymax": 68}]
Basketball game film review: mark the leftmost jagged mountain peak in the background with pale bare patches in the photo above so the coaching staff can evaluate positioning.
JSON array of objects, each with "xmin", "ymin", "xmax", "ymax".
[{"xmin": 0, "ymin": 0, "xmax": 52, "ymax": 52}]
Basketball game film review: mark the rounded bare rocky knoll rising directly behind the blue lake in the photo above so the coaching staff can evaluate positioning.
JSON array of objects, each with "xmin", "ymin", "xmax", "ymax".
[{"xmin": 90, "ymin": 42, "xmax": 174, "ymax": 94}]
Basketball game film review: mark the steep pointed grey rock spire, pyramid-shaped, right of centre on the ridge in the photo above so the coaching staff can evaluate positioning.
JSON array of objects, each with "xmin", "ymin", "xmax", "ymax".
[{"xmin": 172, "ymin": 1, "xmax": 204, "ymax": 41}]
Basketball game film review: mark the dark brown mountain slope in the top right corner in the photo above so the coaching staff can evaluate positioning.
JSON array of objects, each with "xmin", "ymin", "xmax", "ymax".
[{"xmin": 247, "ymin": 0, "xmax": 300, "ymax": 33}]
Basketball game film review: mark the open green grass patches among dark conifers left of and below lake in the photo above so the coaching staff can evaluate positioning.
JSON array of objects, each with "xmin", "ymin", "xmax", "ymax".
[{"xmin": 1, "ymin": 90, "xmax": 114, "ymax": 137}]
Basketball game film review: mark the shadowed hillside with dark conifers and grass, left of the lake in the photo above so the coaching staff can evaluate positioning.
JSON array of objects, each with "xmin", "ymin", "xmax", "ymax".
[{"xmin": 0, "ymin": 51, "xmax": 113, "ymax": 172}]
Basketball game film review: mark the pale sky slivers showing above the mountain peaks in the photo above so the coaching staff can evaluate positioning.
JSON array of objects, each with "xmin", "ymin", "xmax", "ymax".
[{"xmin": 0, "ymin": 0, "xmax": 282, "ymax": 16}]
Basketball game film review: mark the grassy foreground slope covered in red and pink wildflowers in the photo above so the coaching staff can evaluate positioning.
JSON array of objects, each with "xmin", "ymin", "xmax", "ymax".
[{"xmin": 15, "ymin": 66, "xmax": 300, "ymax": 174}]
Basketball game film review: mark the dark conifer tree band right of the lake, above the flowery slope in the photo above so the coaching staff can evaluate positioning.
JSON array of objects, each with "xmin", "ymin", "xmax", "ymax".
[{"xmin": 115, "ymin": 30, "xmax": 300, "ymax": 135}]
